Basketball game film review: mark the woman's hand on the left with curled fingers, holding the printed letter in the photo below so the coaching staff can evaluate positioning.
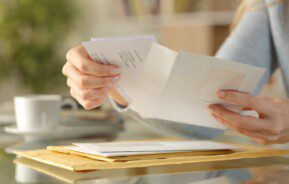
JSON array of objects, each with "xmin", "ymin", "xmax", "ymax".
[{"xmin": 62, "ymin": 46, "xmax": 127, "ymax": 110}]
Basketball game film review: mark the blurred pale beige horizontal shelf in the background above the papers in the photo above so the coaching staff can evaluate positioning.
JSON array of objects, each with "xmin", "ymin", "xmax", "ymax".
[{"xmin": 91, "ymin": 11, "xmax": 235, "ymax": 35}]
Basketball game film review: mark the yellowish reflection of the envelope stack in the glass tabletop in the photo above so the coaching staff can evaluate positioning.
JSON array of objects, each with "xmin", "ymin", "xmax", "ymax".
[{"xmin": 16, "ymin": 157, "xmax": 289, "ymax": 184}]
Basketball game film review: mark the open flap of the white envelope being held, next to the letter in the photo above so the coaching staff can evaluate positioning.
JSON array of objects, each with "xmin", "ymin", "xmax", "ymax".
[{"xmin": 130, "ymin": 43, "xmax": 177, "ymax": 117}]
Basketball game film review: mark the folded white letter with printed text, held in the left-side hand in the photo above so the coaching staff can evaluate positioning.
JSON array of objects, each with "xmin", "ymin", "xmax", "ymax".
[{"xmin": 82, "ymin": 36, "xmax": 156, "ymax": 102}]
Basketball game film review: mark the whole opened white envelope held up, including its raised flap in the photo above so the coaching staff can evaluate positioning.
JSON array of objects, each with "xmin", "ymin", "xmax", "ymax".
[{"xmin": 131, "ymin": 44, "xmax": 265, "ymax": 129}]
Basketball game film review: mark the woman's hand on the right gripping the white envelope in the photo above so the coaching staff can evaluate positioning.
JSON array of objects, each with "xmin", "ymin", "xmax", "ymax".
[{"xmin": 209, "ymin": 90, "xmax": 289, "ymax": 144}]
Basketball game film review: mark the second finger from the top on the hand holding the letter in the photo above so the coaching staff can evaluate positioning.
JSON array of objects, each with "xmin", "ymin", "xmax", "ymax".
[{"xmin": 67, "ymin": 64, "xmax": 120, "ymax": 89}]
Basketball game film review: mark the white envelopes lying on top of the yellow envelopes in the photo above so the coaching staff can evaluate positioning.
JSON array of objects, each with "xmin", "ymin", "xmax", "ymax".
[{"xmin": 67, "ymin": 141, "xmax": 241, "ymax": 157}]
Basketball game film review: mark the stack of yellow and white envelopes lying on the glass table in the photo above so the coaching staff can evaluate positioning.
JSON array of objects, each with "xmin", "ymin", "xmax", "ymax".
[{"xmin": 15, "ymin": 140, "xmax": 289, "ymax": 171}]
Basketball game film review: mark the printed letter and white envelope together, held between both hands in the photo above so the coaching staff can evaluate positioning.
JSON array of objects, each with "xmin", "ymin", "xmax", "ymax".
[{"xmin": 83, "ymin": 36, "xmax": 265, "ymax": 129}]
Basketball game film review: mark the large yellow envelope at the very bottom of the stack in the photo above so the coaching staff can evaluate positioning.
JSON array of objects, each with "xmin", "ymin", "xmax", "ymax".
[{"xmin": 15, "ymin": 147, "xmax": 289, "ymax": 171}]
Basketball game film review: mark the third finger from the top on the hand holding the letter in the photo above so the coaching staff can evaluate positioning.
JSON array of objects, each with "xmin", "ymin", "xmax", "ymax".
[{"xmin": 67, "ymin": 78, "xmax": 111, "ymax": 100}]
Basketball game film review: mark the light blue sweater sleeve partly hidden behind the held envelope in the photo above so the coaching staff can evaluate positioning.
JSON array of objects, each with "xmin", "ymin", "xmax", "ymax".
[{"xmin": 112, "ymin": 0, "xmax": 276, "ymax": 139}]
